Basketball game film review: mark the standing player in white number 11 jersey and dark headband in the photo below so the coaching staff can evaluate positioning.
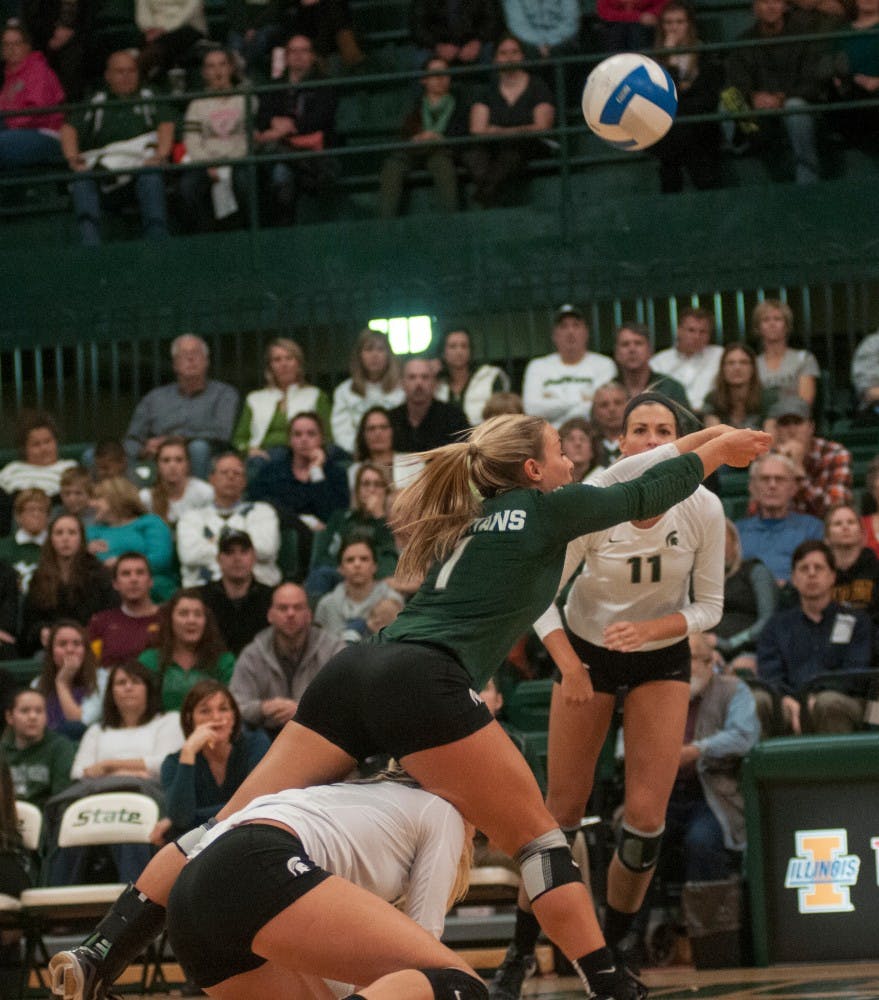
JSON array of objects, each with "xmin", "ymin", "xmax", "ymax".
[{"xmin": 489, "ymin": 392, "xmax": 725, "ymax": 1000}]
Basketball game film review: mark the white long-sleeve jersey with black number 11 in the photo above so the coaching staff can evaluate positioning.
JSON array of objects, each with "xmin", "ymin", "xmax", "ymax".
[{"xmin": 534, "ymin": 445, "xmax": 725, "ymax": 651}]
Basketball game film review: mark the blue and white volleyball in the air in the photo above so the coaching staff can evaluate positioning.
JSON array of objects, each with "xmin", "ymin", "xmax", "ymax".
[{"xmin": 582, "ymin": 52, "xmax": 678, "ymax": 150}]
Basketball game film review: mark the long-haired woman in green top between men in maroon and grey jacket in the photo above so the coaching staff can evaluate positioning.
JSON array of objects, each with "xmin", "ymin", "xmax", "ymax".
[{"xmin": 138, "ymin": 590, "xmax": 235, "ymax": 712}]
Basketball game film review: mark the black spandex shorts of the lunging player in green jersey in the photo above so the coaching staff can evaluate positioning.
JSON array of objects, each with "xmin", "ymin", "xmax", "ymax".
[{"xmin": 295, "ymin": 642, "xmax": 492, "ymax": 760}]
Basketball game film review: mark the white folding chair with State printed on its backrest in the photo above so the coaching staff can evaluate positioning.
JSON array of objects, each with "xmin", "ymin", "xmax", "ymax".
[{"xmin": 21, "ymin": 792, "xmax": 159, "ymax": 988}]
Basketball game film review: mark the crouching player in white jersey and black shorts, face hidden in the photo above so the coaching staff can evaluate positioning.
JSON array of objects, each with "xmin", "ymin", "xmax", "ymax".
[{"xmin": 168, "ymin": 780, "xmax": 485, "ymax": 1000}]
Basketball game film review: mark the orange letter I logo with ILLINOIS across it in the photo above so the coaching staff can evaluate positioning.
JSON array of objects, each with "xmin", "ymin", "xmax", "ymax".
[{"xmin": 784, "ymin": 829, "xmax": 861, "ymax": 913}]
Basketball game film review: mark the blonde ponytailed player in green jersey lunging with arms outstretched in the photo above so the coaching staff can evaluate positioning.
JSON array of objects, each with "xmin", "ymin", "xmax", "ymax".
[{"xmin": 49, "ymin": 416, "xmax": 770, "ymax": 1000}]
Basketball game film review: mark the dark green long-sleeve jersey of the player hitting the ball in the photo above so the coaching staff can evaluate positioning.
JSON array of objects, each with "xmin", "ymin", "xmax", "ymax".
[{"xmin": 377, "ymin": 454, "xmax": 703, "ymax": 690}]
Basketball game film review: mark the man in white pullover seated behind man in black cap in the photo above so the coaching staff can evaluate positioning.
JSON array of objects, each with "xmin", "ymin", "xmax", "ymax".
[{"xmin": 177, "ymin": 451, "xmax": 281, "ymax": 587}]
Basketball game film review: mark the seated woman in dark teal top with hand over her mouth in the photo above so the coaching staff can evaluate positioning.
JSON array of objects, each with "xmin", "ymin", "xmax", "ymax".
[{"xmin": 154, "ymin": 679, "xmax": 269, "ymax": 842}]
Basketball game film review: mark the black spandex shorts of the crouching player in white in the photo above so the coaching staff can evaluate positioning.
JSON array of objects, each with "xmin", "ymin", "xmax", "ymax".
[{"xmin": 168, "ymin": 823, "xmax": 330, "ymax": 989}]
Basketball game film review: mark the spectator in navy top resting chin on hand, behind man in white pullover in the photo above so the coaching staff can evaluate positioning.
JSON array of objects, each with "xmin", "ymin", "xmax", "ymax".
[{"xmin": 248, "ymin": 413, "xmax": 349, "ymax": 566}]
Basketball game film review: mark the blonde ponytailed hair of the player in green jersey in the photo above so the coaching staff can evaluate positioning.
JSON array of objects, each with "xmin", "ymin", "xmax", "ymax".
[{"xmin": 390, "ymin": 414, "xmax": 547, "ymax": 579}]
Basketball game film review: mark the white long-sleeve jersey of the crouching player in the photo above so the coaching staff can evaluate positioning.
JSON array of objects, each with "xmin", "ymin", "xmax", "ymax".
[{"xmin": 189, "ymin": 781, "xmax": 464, "ymax": 940}]
